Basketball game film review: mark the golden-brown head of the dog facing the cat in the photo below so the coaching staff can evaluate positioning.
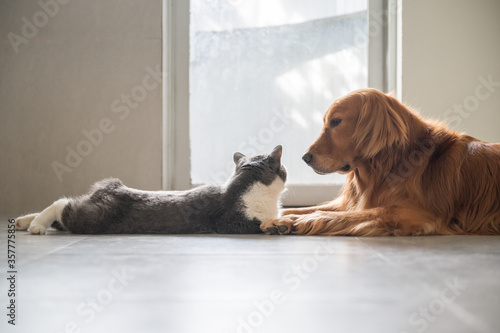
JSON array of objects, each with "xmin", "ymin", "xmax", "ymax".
[{"xmin": 302, "ymin": 89, "xmax": 408, "ymax": 174}]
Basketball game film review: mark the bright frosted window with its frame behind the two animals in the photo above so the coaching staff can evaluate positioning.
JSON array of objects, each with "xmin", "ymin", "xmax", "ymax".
[{"xmin": 164, "ymin": 0, "xmax": 396, "ymax": 205}]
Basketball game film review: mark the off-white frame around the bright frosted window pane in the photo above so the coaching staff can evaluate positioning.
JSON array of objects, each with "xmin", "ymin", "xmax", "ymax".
[{"xmin": 162, "ymin": 0, "xmax": 401, "ymax": 206}]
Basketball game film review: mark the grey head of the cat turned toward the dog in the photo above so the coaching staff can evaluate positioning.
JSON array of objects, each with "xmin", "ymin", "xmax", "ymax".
[{"xmin": 233, "ymin": 145, "xmax": 287, "ymax": 185}]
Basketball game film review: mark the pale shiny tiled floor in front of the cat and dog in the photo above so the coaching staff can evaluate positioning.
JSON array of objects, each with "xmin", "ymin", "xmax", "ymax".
[{"xmin": 0, "ymin": 219, "xmax": 500, "ymax": 333}]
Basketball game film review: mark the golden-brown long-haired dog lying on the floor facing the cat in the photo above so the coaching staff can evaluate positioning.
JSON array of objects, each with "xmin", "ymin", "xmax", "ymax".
[{"xmin": 261, "ymin": 89, "xmax": 500, "ymax": 236}]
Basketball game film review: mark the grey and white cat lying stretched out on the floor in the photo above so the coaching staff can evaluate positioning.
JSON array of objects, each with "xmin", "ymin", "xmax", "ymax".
[{"xmin": 15, "ymin": 146, "xmax": 286, "ymax": 235}]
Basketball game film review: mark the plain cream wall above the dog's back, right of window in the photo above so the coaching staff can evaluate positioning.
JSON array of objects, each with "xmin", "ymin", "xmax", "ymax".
[{"xmin": 402, "ymin": 0, "xmax": 500, "ymax": 142}]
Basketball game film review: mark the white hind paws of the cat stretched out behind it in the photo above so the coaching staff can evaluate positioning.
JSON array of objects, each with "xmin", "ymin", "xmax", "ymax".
[{"xmin": 15, "ymin": 198, "xmax": 71, "ymax": 235}]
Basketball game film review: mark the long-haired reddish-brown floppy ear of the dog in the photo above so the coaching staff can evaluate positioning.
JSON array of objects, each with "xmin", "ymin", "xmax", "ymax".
[{"xmin": 354, "ymin": 92, "xmax": 409, "ymax": 158}]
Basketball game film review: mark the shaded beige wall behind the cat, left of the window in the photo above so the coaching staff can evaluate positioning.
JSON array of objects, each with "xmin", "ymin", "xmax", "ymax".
[{"xmin": 0, "ymin": 0, "xmax": 162, "ymax": 214}]
